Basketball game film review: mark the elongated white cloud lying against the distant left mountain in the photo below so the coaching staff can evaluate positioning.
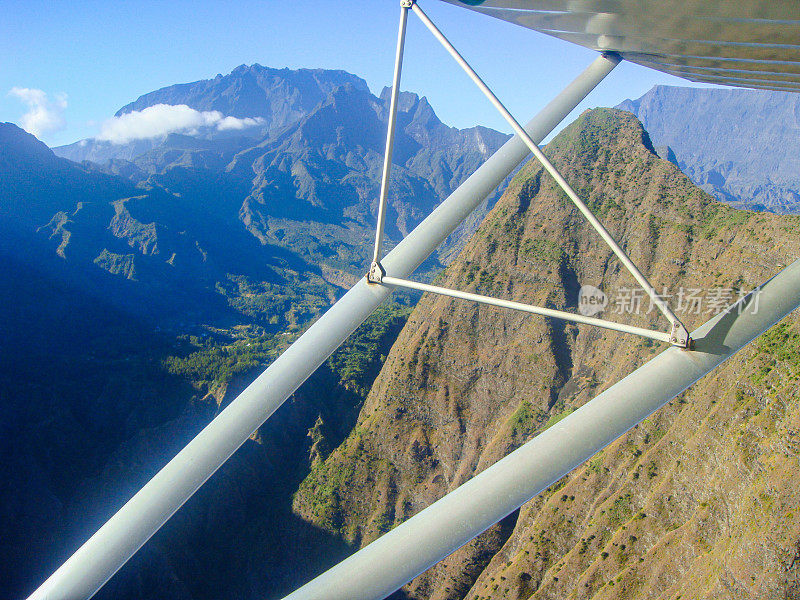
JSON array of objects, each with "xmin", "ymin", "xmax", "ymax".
[{"xmin": 97, "ymin": 104, "xmax": 264, "ymax": 144}]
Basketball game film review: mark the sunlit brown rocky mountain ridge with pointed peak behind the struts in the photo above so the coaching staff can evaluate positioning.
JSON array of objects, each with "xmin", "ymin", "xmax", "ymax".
[{"xmin": 294, "ymin": 109, "xmax": 800, "ymax": 600}]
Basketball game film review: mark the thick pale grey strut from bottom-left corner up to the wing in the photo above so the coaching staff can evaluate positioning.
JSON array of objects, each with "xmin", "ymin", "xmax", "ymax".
[{"xmin": 30, "ymin": 55, "xmax": 619, "ymax": 600}]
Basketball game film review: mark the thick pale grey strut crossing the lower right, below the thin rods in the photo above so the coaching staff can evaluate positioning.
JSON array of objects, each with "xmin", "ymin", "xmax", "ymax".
[{"xmin": 284, "ymin": 260, "xmax": 800, "ymax": 600}]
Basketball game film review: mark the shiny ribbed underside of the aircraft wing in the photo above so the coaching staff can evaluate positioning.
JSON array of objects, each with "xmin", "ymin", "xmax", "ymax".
[{"xmin": 444, "ymin": 0, "xmax": 800, "ymax": 91}]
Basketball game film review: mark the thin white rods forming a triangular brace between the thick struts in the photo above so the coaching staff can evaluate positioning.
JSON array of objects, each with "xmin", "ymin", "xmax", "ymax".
[{"xmin": 368, "ymin": 0, "xmax": 691, "ymax": 348}]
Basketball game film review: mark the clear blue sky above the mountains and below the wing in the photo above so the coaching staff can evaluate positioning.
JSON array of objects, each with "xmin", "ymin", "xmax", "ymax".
[{"xmin": 0, "ymin": 0, "xmax": 712, "ymax": 146}]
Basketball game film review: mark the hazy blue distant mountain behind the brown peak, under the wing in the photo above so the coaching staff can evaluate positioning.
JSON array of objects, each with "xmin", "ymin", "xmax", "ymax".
[{"xmin": 618, "ymin": 85, "xmax": 800, "ymax": 213}]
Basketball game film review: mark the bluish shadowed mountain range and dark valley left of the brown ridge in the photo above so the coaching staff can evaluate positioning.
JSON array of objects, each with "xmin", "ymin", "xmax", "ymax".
[{"xmin": 0, "ymin": 65, "xmax": 507, "ymax": 598}]
